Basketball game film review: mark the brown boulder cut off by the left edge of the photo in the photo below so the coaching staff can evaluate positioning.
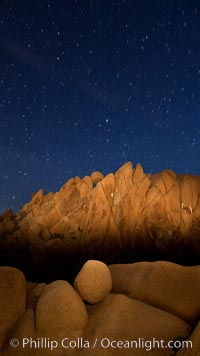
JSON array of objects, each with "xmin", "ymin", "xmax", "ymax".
[{"xmin": 0, "ymin": 267, "xmax": 26, "ymax": 349}]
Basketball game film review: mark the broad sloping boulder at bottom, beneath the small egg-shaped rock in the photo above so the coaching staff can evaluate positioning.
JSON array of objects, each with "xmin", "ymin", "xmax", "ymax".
[{"xmin": 81, "ymin": 294, "xmax": 192, "ymax": 356}]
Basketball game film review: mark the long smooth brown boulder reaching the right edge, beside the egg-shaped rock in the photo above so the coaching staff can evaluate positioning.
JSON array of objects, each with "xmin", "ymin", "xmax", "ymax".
[{"xmin": 109, "ymin": 261, "xmax": 200, "ymax": 324}]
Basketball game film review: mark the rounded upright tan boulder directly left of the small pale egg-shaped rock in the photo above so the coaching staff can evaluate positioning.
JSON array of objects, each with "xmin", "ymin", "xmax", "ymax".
[{"xmin": 35, "ymin": 281, "xmax": 88, "ymax": 335}]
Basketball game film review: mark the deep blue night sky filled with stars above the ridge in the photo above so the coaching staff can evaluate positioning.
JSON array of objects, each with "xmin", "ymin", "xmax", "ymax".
[{"xmin": 0, "ymin": 0, "xmax": 200, "ymax": 213}]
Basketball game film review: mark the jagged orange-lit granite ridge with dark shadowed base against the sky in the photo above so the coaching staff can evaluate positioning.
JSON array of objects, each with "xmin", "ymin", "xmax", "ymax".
[{"xmin": 0, "ymin": 162, "xmax": 200, "ymax": 281}]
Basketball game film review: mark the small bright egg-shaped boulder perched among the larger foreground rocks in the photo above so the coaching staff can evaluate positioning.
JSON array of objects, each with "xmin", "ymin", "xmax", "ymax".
[{"xmin": 74, "ymin": 260, "xmax": 112, "ymax": 304}]
